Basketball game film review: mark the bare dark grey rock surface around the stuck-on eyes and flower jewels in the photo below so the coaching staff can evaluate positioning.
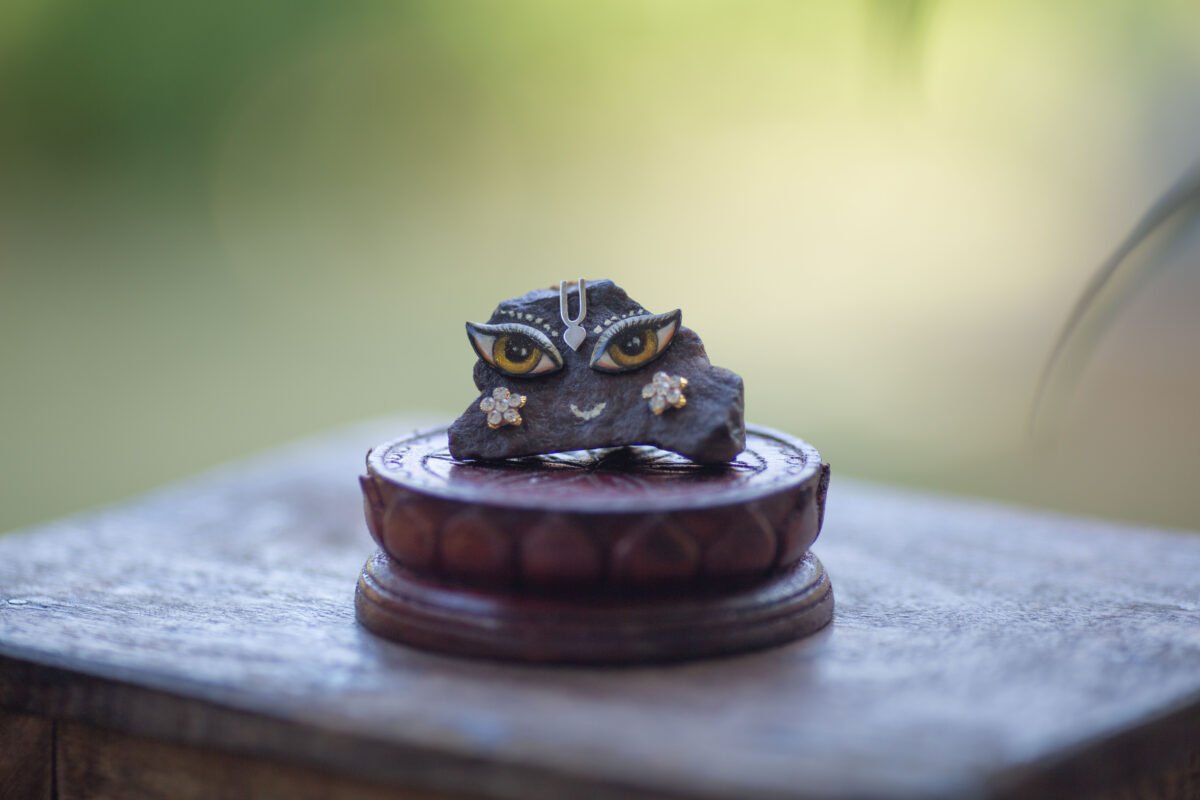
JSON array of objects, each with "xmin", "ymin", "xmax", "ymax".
[{"xmin": 449, "ymin": 281, "xmax": 745, "ymax": 464}]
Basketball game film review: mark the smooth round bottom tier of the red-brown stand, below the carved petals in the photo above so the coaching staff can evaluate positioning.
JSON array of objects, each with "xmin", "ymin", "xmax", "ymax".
[{"xmin": 355, "ymin": 553, "xmax": 833, "ymax": 664}]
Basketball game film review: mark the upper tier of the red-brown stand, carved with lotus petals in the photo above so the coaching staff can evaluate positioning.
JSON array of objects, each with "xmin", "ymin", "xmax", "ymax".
[{"xmin": 360, "ymin": 426, "xmax": 829, "ymax": 587}]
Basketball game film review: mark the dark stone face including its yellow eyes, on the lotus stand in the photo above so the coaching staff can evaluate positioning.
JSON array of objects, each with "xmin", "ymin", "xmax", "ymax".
[{"xmin": 449, "ymin": 281, "xmax": 745, "ymax": 464}]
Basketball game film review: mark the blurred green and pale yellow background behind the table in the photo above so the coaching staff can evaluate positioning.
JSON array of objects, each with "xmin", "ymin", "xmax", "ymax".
[{"xmin": 0, "ymin": 0, "xmax": 1200, "ymax": 530}]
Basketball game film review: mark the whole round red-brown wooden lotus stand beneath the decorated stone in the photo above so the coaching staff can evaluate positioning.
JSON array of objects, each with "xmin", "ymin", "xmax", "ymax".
[{"xmin": 356, "ymin": 427, "xmax": 833, "ymax": 663}]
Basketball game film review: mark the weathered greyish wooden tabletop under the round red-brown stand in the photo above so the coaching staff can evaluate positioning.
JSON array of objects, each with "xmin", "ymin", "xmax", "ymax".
[{"xmin": 0, "ymin": 426, "xmax": 1200, "ymax": 798}]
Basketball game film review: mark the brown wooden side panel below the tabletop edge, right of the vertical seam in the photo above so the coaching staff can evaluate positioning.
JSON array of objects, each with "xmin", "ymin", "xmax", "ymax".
[{"xmin": 56, "ymin": 722, "xmax": 451, "ymax": 800}]
